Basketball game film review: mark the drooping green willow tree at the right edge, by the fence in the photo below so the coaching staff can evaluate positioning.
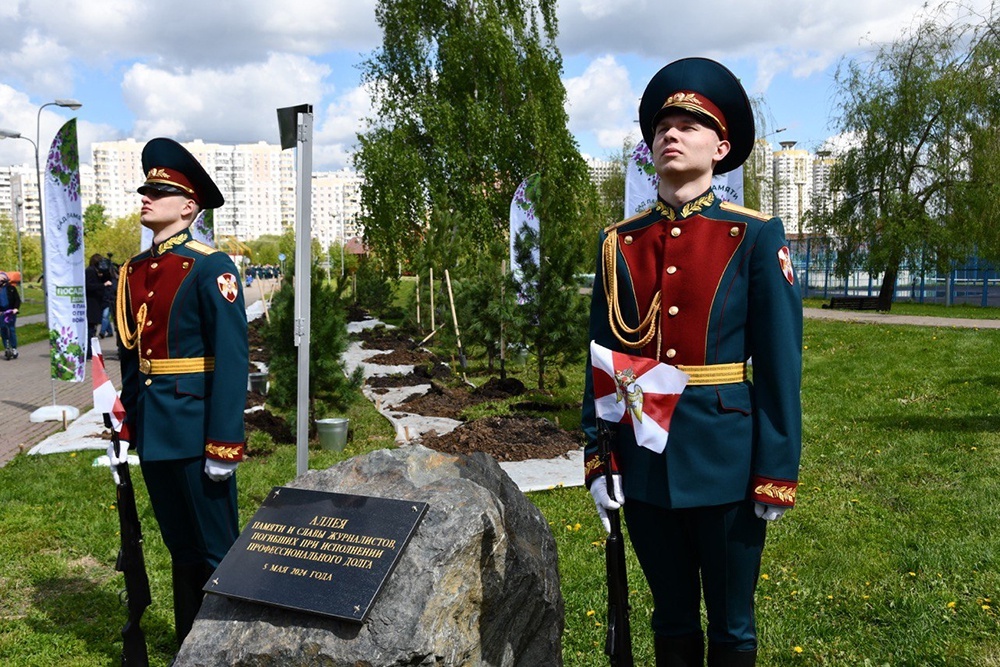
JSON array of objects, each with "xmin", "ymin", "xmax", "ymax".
[{"xmin": 819, "ymin": 3, "xmax": 1000, "ymax": 310}]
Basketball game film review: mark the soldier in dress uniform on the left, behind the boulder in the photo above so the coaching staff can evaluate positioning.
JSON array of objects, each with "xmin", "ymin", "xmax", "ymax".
[{"xmin": 108, "ymin": 138, "xmax": 249, "ymax": 643}]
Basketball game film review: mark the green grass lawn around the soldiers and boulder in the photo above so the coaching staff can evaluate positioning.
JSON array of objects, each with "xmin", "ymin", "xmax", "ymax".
[{"xmin": 0, "ymin": 306, "xmax": 1000, "ymax": 667}]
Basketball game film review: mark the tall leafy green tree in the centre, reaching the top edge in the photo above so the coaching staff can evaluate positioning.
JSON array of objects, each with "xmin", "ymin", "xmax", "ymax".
[{"xmin": 355, "ymin": 0, "xmax": 597, "ymax": 388}]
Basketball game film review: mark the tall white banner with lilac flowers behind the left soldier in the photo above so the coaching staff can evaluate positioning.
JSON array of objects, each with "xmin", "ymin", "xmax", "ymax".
[{"xmin": 44, "ymin": 118, "xmax": 87, "ymax": 382}]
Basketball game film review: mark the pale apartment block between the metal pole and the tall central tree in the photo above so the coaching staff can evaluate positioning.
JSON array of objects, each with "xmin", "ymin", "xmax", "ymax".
[{"xmin": 312, "ymin": 169, "xmax": 364, "ymax": 250}]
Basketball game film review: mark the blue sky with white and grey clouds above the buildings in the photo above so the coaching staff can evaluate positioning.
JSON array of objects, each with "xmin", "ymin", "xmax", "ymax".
[{"xmin": 0, "ymin": 0, "xmax": 990, "ymax": 171}]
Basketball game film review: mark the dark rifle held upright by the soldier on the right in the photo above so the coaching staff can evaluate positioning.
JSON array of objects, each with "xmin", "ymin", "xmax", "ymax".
[{"xmin": 597, "ymin": 419, "xmax": 635, "ymax": 667}]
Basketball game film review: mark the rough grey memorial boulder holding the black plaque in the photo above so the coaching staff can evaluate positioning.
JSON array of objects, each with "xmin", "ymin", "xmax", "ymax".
[{"xmin": 176, "ymin": 445, "xmax": 563, "ymax": 667}]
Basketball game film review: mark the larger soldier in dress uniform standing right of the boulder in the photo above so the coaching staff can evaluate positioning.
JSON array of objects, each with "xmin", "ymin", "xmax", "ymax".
[{"xmin": 583, "ymin": 58, "xmax": 802, "ymax": 667}]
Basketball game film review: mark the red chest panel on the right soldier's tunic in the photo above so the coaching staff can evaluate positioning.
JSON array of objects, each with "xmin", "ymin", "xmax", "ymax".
[{"xmin": 619, "ymin": 215, "xmax": 746, "ymax": 365}]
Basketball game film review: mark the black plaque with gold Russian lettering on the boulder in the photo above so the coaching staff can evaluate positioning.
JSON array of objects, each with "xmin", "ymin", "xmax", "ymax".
[{"xmin": 205, "ymin": 486, "xmax": 427, "ymax": 623}]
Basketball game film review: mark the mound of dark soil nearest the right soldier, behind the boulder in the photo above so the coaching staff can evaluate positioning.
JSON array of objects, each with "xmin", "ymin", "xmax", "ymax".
[{"xmin": 421, "ymin": 416, "xmax": 582, "ymax": 461}]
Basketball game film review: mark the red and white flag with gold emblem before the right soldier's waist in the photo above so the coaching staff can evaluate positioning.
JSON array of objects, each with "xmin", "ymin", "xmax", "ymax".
[{"xmin": 590, "ymin": 341, "xmax": 689, "ymax": 454}]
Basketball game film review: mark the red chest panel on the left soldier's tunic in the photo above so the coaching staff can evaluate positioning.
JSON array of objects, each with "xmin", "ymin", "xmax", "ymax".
[{"xmin": 128, "ymin": 253, "xmax": 195, "ymax": 359}]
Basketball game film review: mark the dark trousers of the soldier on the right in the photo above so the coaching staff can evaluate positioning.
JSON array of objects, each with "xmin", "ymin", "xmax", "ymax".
[{"xmin": 624, "ymin": 500, "xmax": 766, "ymax": 651}]
